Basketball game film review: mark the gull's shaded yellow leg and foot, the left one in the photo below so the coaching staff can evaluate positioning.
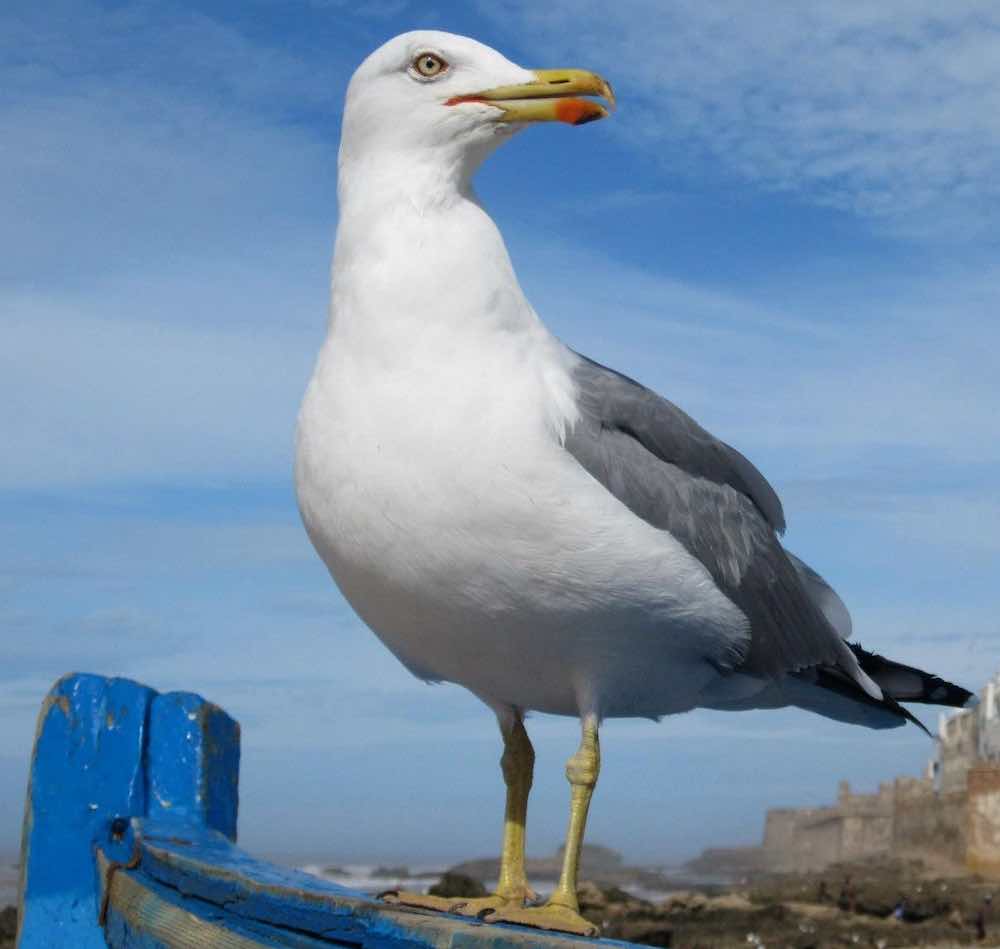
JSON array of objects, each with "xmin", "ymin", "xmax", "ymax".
[{"xmin": 454, "ymin": 712, "xmax": 535, "ymax": 916}]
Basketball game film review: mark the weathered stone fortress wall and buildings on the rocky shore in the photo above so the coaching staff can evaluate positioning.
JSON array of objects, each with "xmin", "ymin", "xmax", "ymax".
[{"xmin": 760, "ymin": 674, "xmax": 1000, "ymax": 877}]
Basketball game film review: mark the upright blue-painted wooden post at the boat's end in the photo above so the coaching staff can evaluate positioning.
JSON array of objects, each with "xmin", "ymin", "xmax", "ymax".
[{"xmin": 18, "ymin": 675, "xmax": 239, "ymax": 949}]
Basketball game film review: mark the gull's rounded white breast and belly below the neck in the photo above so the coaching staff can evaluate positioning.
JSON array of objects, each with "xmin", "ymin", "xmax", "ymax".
[{"xmin": 296, "ymin": 322, "xmax": 745, "ymax": 715}]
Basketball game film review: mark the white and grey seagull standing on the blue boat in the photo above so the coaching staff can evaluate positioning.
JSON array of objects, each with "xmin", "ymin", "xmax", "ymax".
[{"xmin": 295, "ymin": 31, "xmax": 971, "ymax": 934}]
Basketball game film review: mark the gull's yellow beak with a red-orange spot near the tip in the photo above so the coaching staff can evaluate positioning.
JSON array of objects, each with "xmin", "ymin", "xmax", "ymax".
[{"xmin": 445, "ymin": 69, "xmax": 615, "ymax": 125}]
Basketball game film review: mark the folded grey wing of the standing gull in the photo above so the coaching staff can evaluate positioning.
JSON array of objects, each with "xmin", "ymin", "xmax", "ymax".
[{"xmin": 565, "ymin": 357, "xmax": 880, "ymax": 684}]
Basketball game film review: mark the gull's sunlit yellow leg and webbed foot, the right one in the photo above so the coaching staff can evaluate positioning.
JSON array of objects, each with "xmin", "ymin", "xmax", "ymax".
[{"xmin": 485, "ymin": 715, "xmax": 601, "ymax": 936}]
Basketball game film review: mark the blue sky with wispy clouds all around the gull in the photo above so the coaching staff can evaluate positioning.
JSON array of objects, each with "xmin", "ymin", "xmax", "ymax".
[{"xmin": 0, "ymin": 0, "xmax": 1000, "ymax": 861}]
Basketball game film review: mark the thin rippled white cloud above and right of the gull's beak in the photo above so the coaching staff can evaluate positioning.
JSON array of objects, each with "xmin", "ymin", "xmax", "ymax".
[{"xmin": 481, "ymin": 0, "xmax": 1000, "ymax": 238}]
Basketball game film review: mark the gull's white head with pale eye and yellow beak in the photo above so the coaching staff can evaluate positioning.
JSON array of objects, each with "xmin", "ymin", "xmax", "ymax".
[{"xmin": 341, "ymin": 30, "xmax": 614, "ymax": 181}]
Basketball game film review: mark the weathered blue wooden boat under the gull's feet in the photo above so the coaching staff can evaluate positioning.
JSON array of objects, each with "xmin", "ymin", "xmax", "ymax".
[{"xmin": 17, "ymin": 675, "xmax": 629, "ymax": 949}]
